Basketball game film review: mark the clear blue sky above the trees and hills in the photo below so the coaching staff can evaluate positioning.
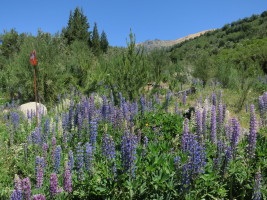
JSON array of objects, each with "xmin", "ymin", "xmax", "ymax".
[{"xmin": 0, "ymin": 0, "xmax": 267, "ymax": 46}]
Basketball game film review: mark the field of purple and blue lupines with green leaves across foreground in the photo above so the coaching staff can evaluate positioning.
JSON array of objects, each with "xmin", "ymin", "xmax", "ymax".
[{"xmin": 0, "ymin": 88, "xmax": 267, "ymax": 200}]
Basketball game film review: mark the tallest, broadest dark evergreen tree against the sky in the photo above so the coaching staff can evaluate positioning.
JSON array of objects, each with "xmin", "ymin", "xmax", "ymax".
[{"xmin": 62, "ymin": 7, "xmax": 90, "ymax": 44}]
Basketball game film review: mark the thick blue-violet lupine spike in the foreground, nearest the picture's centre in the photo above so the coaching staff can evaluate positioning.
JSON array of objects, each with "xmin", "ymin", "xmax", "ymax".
[{"xmin": 121, "ymin": 132, "xmax": 137, "ymax": 177}]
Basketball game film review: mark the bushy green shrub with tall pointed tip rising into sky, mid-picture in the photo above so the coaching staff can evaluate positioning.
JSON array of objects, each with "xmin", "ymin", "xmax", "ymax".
[{"xmin": 104, "ymin": 32, "xmax": 149, "ymax": 100}]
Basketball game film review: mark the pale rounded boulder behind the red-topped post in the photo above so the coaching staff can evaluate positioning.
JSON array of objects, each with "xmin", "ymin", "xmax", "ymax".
[{"xmin": 18, "ymin": 102, "xmax": 47, "ymax": 117}]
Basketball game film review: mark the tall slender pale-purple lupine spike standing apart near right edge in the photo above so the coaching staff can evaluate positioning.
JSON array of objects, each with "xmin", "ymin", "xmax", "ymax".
[{"xmin": 247, "ymin": 104, "xmax": 257, "ymax": 158}]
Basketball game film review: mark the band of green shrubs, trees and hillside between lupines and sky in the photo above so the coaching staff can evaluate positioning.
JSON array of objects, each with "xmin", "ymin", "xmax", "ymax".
[{"xmin": 0, "ymin": 8, "xmax": 267, "ymax": 106}]
